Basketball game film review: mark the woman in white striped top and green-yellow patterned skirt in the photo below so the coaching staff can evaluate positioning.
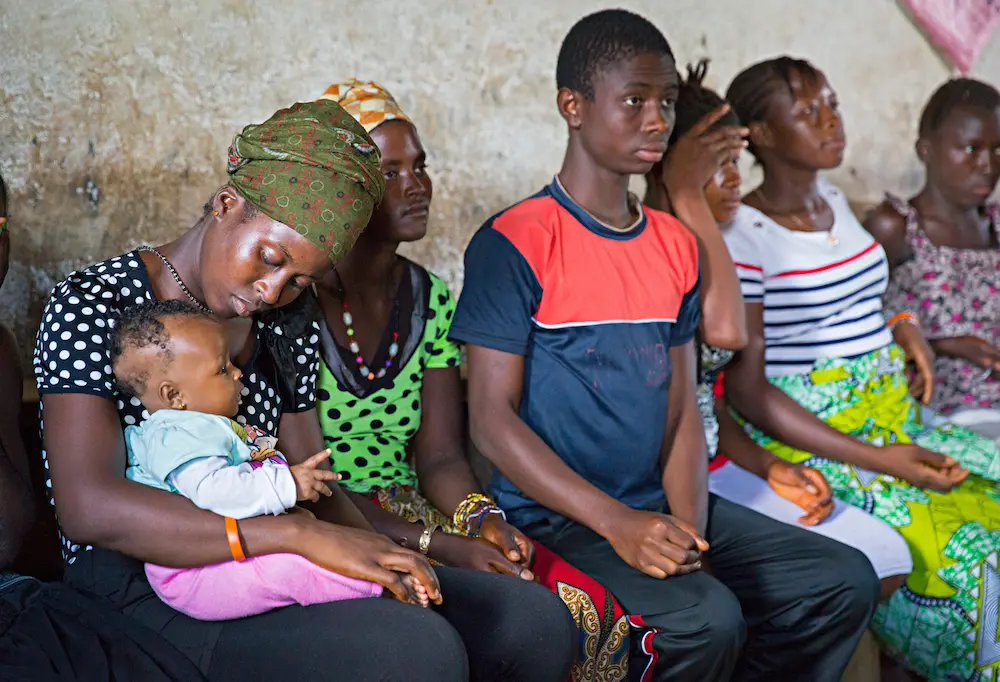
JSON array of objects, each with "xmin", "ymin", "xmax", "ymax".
[{"xmin": 725, "ymin": 57, "xmax": 1000, "ymax": 682}]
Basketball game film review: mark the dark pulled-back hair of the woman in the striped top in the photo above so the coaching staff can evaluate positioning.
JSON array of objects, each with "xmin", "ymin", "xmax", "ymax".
[{"xmin": 726, "ymin": 55, "xmax": 823, "ymax": 161}]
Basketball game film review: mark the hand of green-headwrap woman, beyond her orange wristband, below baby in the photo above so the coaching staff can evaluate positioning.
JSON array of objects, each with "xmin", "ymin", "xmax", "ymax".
[{"xmin": 290, "ymin": 513, "xmax": 441, "ymax": 605}]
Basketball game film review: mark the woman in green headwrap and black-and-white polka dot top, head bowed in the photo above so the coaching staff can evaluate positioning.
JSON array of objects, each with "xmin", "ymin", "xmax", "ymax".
[{"xmin": 35, "ymin": 101, "xmax": 574, "ymax": 682}]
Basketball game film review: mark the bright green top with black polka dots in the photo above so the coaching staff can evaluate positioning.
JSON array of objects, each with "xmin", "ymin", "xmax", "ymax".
[{"xmin": 316, "ymin": 266, "xmax": 460, "ymax": 493}]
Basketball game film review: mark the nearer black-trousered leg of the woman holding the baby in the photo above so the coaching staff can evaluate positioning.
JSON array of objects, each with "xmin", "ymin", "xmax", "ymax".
[{"xmin": 126, "ymin": 564, "xmax": 468, "ymax": 682}]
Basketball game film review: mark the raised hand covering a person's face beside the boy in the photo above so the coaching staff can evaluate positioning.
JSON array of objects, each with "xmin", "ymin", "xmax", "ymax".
[{"xmin": 663, "ymin": 103, "xmax": 750, "ymax": 196}]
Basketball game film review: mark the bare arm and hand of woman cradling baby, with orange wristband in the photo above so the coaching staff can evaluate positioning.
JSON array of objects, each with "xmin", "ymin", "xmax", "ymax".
[{"xmin": 42, "ymin": 394, "xmax": 440, "ymax": 601}]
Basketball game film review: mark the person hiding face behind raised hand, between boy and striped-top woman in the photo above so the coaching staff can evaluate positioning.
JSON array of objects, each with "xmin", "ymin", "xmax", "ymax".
[{"xmin": 643, "ymin": 60, "xmax": 912, "ymax": 598}]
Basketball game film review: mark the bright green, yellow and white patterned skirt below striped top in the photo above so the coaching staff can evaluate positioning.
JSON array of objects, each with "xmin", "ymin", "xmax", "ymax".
[{"xmin": 755, "ymin": 348, "xmax": 1000, "ymax": 682}]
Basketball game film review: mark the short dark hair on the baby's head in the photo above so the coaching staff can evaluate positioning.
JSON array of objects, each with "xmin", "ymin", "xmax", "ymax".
[{"xmin": 111, "ymin": 301, "xmax": 215, "ymax": 397}]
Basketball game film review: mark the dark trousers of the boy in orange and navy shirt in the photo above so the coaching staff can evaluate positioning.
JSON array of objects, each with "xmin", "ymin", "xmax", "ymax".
[{"xmin": 524, "ymin": 495, "xmax": 879, "ymax": 682}]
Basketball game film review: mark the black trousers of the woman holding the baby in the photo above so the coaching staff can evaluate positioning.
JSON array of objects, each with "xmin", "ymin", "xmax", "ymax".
[{"xmin": 67, "ymin": 549, "xmax": 576, "ymax": 682}]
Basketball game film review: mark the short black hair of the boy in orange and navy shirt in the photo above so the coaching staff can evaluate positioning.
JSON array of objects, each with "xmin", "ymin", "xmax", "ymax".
[{"xmin": 556, "ymin": 9, "xmax": 674, "ymax": 100}]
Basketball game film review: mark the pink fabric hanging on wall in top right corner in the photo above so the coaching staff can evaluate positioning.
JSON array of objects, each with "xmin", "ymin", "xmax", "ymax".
[{"xmin": 902, "ymin": 0, "xmax": 1000, "ymax": 74}]
